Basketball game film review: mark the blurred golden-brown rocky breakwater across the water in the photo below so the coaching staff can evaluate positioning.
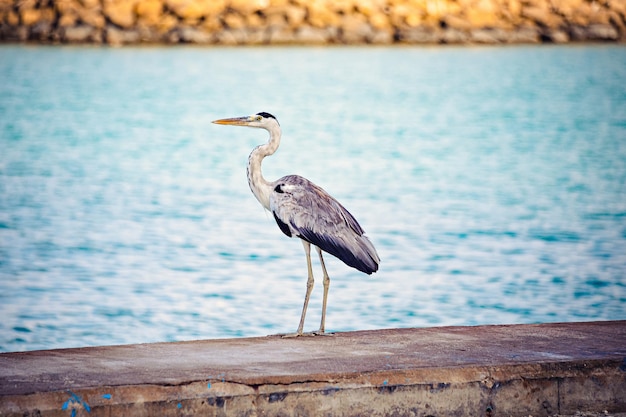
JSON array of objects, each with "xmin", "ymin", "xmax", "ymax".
[{"xmin": 0, "ymin": 0, "xmax": 626, "ymax": 45}]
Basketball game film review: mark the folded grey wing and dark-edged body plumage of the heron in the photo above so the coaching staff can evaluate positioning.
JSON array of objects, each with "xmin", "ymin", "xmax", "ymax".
[{"xmin": 270, "ymin": 175, "xmax": 380, "ymax": 274}]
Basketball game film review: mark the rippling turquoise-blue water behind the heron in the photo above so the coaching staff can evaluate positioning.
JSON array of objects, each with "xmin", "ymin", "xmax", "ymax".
[{"xmin": 0, "ymin": 45, "xmax": 626, "ymax": 351}]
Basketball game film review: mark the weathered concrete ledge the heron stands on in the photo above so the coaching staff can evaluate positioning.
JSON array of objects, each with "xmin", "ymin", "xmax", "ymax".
[{"xmin": 0, "ymin": 321, "xmax": 626, "ymax": 416}]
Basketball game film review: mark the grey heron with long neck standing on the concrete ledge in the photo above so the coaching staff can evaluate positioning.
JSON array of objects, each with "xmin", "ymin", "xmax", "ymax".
[{"xmin": 213, "ymin": 112, "xmax": 380, "ymax": 336}]
